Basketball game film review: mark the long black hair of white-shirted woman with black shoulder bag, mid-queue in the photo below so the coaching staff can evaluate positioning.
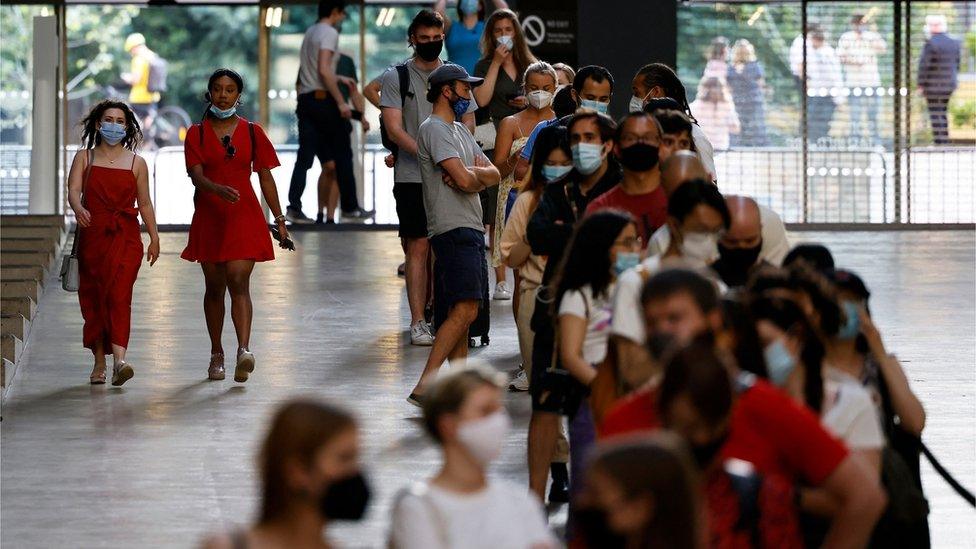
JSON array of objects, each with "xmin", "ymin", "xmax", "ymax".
[{"xmin": 553, "ymin": 210, "xmax": 634, "ymax": 306}]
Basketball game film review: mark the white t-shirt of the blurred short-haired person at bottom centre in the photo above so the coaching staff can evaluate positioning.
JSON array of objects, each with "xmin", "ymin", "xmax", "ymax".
[{"xmin": 390, "ymin": 481, "xmax": 556, "ymax": 549}]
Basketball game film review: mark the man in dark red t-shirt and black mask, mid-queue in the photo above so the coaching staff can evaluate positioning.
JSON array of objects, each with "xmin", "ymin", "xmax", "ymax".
[{"xmin": 586, "ymin": 111, "xmax": 668, "ymax": 244}]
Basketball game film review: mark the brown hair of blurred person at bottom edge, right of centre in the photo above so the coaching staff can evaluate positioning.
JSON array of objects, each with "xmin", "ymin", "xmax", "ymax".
[{"xmin": 587, "ymin": 432, "xmax": 702, "ymax": 548}]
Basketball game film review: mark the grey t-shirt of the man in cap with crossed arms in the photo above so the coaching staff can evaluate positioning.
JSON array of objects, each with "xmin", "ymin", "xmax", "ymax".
[{"xmin": 417, "ymin": 115, "xmax": 488, "ymax": 237}]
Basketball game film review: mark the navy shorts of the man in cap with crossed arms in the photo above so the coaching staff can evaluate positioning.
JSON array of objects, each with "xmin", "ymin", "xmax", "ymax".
[{"xmin": 430, "ymin": 227, "xmax": 488, "ymax": 329}]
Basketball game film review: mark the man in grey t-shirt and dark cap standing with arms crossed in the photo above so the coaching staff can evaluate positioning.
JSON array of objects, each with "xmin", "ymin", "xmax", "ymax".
[{"xmin": 407, "ymin": 63, "xmax": 501, "ymax": 406}]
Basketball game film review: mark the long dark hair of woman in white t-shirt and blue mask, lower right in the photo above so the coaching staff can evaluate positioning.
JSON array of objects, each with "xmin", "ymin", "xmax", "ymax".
[{"xmin": 749, "ymin": 296, "xmax": 824, "ymax": 415}]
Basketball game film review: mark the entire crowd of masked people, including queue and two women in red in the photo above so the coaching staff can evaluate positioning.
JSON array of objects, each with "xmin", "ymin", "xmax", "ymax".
[{"xmin": 69, "ymin": 0, "xmax": 952, "ymax": 549}]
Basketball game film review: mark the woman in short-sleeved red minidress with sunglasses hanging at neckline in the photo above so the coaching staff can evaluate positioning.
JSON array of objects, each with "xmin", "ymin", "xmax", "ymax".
[{"xmin": 182, "ymin": 69, "xmax": 288, "ymax": 382}]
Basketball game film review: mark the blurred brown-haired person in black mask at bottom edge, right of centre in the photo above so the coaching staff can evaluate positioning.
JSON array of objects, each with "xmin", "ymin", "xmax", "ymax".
[{"xmin": 576, "ymin": 433, "xmax": 707, "ymax": 549}]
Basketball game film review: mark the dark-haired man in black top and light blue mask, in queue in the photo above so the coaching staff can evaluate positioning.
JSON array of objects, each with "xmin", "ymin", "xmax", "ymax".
[{"xmin": 526, "ymin": 109, "xmax": 620, "ymax": 500}]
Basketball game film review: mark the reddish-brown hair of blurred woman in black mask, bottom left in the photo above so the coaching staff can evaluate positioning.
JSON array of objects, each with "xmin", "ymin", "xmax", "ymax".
[{"xmin": 258, "ymin": 400, "xmax": 356, "ymax": 524}]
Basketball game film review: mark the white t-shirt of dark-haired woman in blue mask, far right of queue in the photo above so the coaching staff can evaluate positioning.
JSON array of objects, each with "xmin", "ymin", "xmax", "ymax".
[{"xmin": 820, "ymin": 367, "xmax": 885, "ymax": 450}]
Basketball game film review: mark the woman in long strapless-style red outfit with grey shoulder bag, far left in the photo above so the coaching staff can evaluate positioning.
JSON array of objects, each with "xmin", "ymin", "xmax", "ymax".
[{"xmin": 68, "ymin": 101, "xmax": 159, "ymax": 386}]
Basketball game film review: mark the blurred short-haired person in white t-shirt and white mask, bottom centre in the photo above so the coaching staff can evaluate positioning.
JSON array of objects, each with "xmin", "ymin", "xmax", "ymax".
[{"xmin": 389, "ymin": 366, "xmax": 557, "ymax": 549}]
